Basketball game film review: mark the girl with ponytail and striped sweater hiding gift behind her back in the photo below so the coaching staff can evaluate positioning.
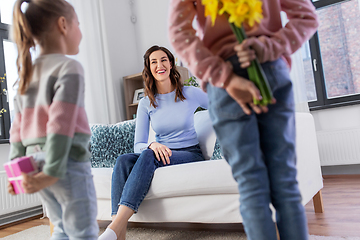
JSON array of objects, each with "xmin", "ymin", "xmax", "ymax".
[{"xmin": 9, "ymin": 0, "xmax": 99, "ymax": 239}]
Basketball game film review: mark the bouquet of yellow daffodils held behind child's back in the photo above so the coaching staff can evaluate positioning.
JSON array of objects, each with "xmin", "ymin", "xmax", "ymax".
[{"xmin": 201, "ymin": 0, "xmax": 273, "ymax": 106}]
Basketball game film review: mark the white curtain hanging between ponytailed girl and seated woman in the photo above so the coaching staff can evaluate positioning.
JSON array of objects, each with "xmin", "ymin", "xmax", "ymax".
[{"xmin": 69, "ymin": 0, "xmax": 116, "ymax": 124}]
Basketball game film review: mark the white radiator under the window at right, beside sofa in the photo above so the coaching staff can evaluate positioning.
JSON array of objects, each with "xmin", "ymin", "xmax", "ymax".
[{"xmin": 317, "ymin": 129, "xmax": 360, "ymax": 166}]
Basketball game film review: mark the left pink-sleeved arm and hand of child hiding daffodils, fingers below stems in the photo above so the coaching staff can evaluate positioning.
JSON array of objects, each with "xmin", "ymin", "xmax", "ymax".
[{"xmin": 169, "ymin": 0, "xmax": 267, "ymax": 114}]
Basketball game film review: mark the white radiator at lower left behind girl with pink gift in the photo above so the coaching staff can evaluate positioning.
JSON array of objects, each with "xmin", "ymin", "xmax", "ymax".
[{"xmin": 0, "ymin": 171, "xmax": 42, "ymax": 225}]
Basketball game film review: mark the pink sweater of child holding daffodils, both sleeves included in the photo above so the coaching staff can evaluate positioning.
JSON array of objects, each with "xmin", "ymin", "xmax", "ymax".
[{"xmin": 169, "ymin": 0, "xmax": 318, "ymax": 90}]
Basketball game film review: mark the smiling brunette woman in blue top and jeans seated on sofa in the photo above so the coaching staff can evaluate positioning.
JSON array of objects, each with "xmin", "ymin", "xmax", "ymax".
[{"xmin": 99, "ymin": 46, "xmax": 208, "ymax": 240}]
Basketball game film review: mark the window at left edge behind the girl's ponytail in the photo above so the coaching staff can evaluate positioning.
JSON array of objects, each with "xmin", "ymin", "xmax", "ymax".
[{"xmin": 0, "ymin": 0, "xmax": 17, "ymax": 143}]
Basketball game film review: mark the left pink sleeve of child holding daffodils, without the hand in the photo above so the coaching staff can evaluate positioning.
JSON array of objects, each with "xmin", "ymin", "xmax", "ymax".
[{"xmin": 169, "ymin": 0, "xmax": 232, "ymax": 90}]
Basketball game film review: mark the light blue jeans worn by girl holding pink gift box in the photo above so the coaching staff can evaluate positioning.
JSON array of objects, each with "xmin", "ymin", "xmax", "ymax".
[{"xmin": 40, "ymin": 158, "xmax": 99, "ymax": 240}]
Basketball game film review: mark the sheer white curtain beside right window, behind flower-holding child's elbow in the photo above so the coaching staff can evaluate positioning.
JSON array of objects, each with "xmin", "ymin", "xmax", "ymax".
[{"xmin": 281, "ymin": 12, "xmax": 309, "ymax": 112}]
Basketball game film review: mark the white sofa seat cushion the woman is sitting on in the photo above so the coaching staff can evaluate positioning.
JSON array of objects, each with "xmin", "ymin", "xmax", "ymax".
[{"xmin": 92, "ymin": 159, "xmax": 238, "ymax": 200}]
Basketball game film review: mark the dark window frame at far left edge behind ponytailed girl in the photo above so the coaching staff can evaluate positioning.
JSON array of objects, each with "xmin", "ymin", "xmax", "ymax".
[{"xmin": 0, "ymin": 14, "xmax": 11, "ymax": 144}]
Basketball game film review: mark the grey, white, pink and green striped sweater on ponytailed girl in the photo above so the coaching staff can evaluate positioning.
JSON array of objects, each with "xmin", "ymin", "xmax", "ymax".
[{"xmin": 10, "ymin": 54, "xmax": 91, "ymax": 178}]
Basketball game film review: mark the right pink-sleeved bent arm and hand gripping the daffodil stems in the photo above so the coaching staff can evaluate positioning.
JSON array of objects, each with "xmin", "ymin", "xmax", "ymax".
[{"xmin": 235, "ymin": 0, "xmax": 319, "ymax": 64}]
